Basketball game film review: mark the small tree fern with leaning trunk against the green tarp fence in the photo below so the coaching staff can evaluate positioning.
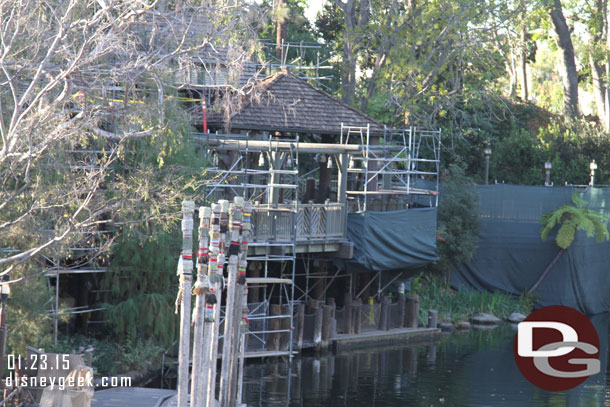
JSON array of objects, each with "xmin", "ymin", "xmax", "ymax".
[{"xmin": 528, "ymin": 192, "xmax": 610, "ymax": 293}]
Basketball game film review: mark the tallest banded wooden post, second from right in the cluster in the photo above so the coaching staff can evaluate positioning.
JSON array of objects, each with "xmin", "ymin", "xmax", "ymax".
[{"xmin": 219, "ymin": 197, "xmax": 244, "ymax": 407}]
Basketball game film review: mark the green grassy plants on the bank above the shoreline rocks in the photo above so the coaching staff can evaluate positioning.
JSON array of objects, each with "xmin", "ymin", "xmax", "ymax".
[{"xmin": 412, "ymin": 274, "xmax": 536, "ymax": 322}]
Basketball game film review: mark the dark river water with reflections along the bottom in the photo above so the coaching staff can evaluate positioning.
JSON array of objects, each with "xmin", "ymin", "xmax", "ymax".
[{"xmin": 244, "ymin": 315, "xmax": 610, "ymax": 407}]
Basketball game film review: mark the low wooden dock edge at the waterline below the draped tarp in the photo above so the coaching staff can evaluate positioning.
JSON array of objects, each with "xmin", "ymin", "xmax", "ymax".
[{"xmin": 330, "ymin": 328, "xmax": 441, "ymax": 352}]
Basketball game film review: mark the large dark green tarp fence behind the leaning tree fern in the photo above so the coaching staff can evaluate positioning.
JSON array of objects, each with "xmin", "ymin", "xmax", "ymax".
[{"xmin": 448, "ymin": 185, "xmax": 610, "ymax": 314}]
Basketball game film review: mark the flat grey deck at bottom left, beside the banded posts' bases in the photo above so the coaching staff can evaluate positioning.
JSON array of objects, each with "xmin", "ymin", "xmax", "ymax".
[{"xmin": 91, "ymin": 387, "xmax": 176, "ymax": 407}]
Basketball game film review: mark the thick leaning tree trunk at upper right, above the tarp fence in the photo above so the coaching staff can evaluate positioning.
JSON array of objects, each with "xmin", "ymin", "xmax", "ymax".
[{"xmin": 551, "ymin": 0, "xmax": 580, "ymax": 119}]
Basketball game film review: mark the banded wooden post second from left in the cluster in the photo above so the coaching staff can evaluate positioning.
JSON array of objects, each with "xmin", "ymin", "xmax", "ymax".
[{"xmin": 191, "ymin": 206, "xmax": 211, "ymax": 406}]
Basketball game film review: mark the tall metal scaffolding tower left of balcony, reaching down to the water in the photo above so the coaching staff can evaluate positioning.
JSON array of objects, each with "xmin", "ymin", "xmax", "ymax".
[{"xmin": 205, "ymin": 135, "xmax": 300, "ymax": 359}]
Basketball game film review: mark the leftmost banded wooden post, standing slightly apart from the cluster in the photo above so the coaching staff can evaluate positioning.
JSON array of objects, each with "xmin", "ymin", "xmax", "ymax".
[{"xmin": 176, "ymin": 201, "xmax": 195, "ymax": 407}]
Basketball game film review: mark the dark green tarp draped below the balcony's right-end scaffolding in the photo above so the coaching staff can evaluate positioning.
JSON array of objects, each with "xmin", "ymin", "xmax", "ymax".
[{"xmin": 347, "ymin": 208, "xmax": 438, "ymax": 271}]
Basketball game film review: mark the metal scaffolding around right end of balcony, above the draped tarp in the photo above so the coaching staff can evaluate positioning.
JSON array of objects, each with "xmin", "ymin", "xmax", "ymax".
[{"xmin": 341, "ymin": 124, "xmax": 441, "ymax": 212}]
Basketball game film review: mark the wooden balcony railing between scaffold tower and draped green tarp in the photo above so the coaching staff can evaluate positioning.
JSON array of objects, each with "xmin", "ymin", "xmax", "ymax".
[{"xmin": 247, "ymin": 202, "xmax": 347, "ymax": 242}]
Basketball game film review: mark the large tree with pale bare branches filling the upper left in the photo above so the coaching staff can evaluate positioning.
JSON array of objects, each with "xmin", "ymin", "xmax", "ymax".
[{"xmin": 0, "ymin": 0, "xmax": 257, "ymax": 350}]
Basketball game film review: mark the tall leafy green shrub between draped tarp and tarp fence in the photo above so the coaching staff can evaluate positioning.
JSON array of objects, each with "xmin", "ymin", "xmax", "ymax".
[{"xmin": 437, "ymin": 164, "xmax": 480, "ymax": 278}]
